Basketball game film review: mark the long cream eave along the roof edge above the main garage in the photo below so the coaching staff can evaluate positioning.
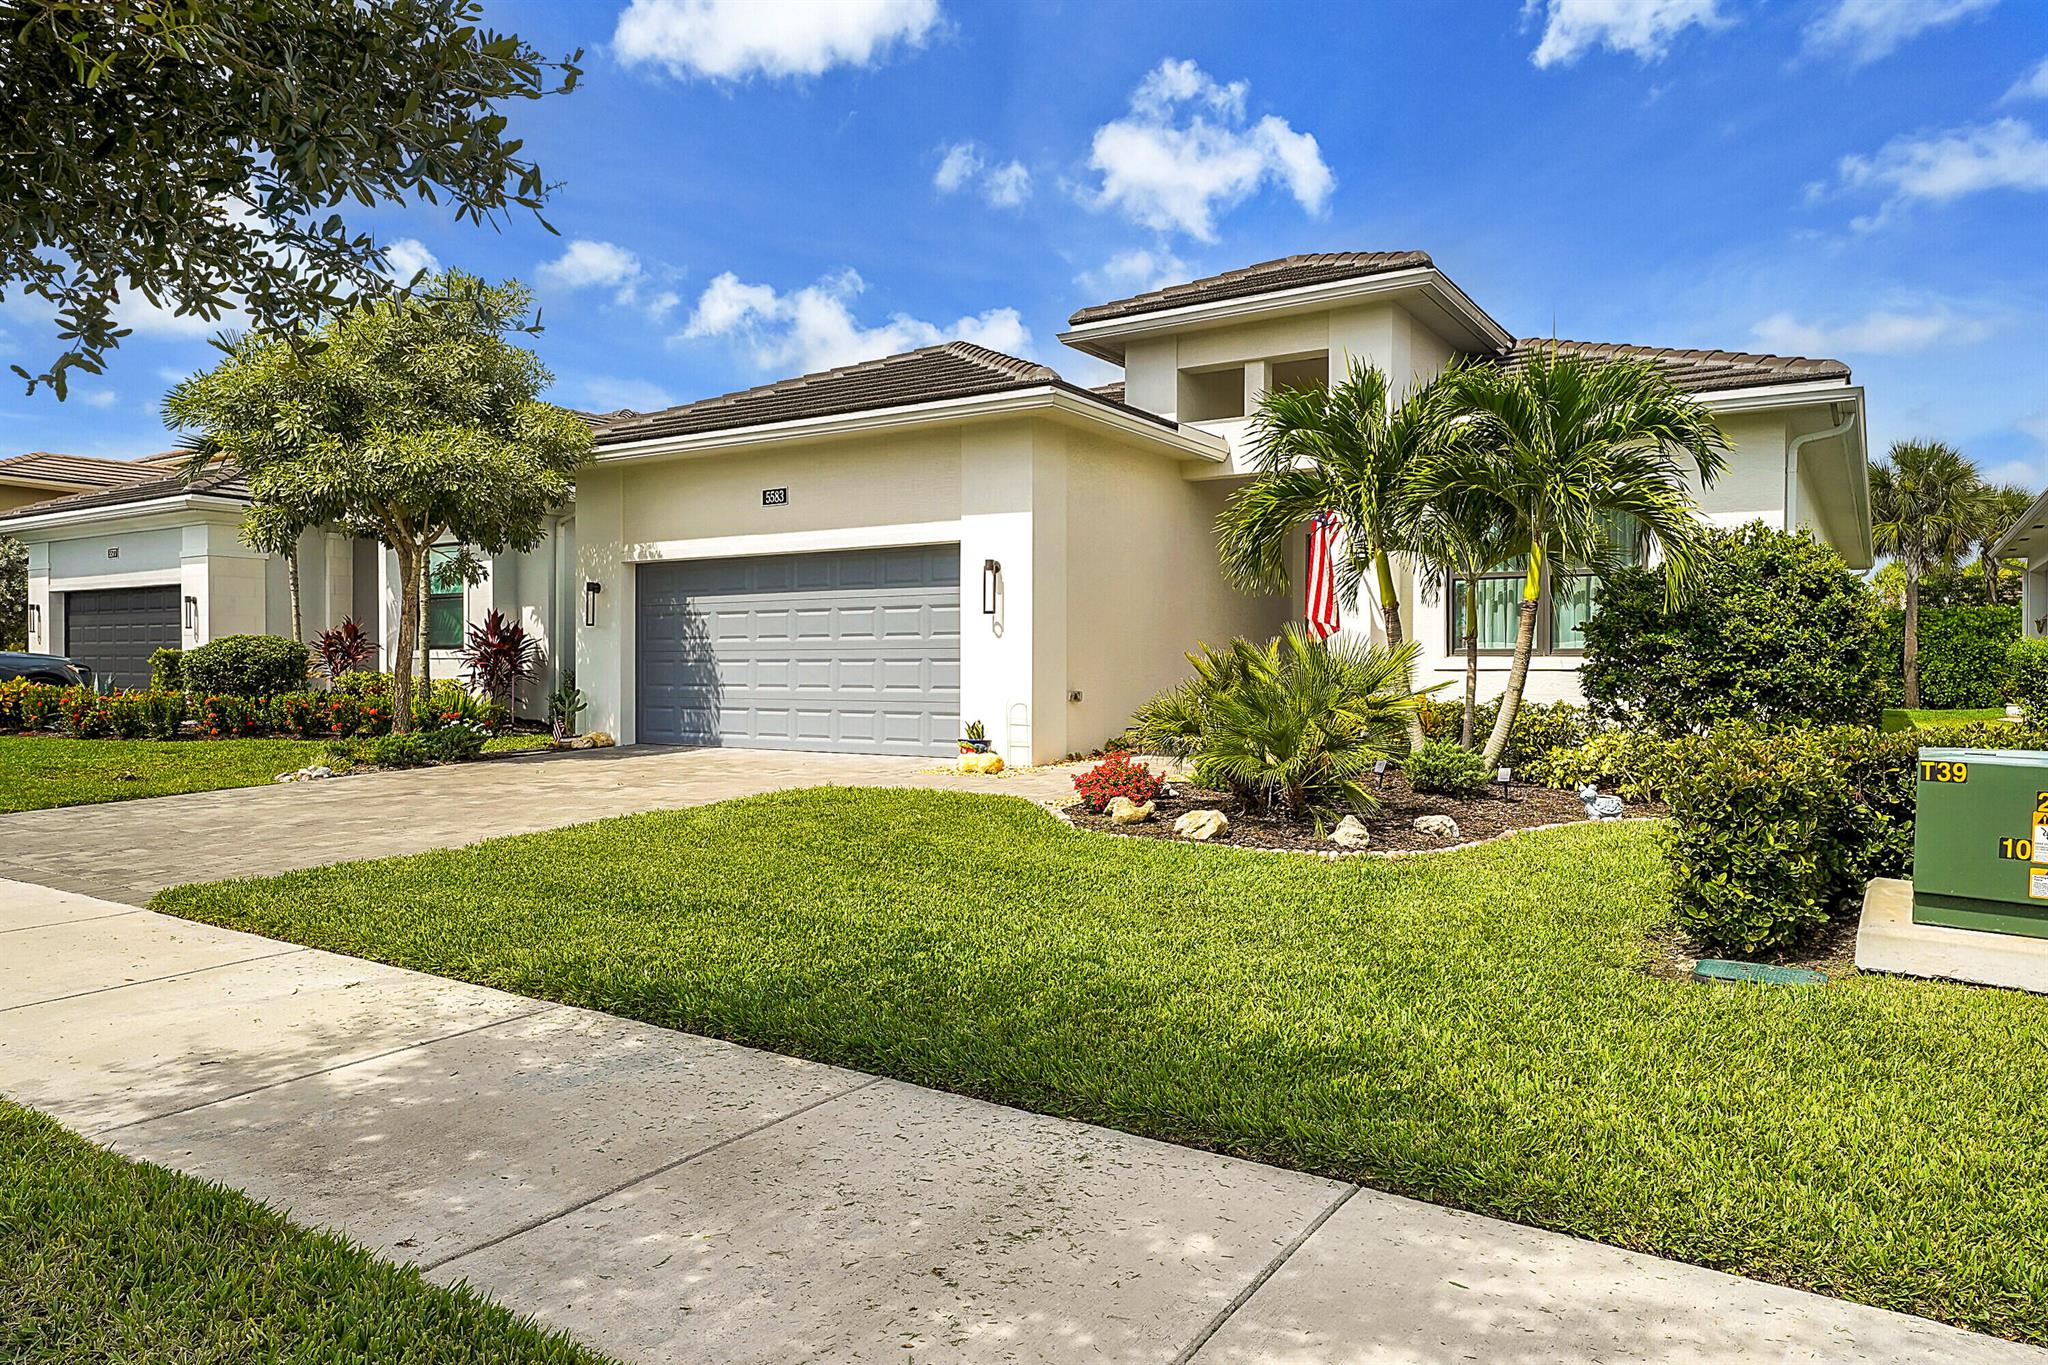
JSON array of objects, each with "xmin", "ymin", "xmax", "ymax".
[{"xmin": 592, "ymin": 385, "xmax": 1231, "ymax": 465}]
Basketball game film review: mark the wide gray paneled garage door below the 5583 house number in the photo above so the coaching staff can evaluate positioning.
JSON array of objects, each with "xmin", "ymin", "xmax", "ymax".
[{"xmin": 635, "ymin": 544, "xmax": 961, "ymax": 753}]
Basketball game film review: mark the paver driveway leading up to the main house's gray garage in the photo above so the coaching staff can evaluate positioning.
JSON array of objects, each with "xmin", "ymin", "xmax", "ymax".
[{"xmin": 0, "ymin": 747, "xmax": 1073, "ymax": 905}]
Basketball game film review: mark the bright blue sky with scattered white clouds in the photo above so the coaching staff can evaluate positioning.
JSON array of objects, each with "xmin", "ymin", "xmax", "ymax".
[{"xmin": 0, "ymin": 0, "xmax": 2048, "ymax": 487}]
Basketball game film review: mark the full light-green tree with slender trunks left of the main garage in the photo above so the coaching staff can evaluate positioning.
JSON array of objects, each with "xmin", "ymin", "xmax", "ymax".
[{"xmin": 164, "ymin": 270, "xmax": 592, "ymax": 729}]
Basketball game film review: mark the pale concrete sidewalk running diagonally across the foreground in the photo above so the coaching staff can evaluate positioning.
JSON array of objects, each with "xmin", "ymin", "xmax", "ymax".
[{"xmin": 0, "ymin": 882, "xmax": 2048, "ymax": 1365}]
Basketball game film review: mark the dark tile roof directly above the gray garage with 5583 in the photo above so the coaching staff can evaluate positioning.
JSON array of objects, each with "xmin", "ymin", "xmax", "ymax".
[{"xmin": 584, "ymin": 342, "xmax": 1171, "ymax": 448}]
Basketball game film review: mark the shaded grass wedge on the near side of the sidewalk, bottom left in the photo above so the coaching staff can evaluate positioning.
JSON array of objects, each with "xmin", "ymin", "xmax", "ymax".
[{"xmin": 0, "ymin": 1101, "xmax": 602, "ymax": 1365}]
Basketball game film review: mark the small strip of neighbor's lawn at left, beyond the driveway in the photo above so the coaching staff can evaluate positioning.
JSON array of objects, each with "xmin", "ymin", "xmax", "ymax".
[{"xmin": 0, "ymin": 735, "xmax": 328, "ymax": 814}]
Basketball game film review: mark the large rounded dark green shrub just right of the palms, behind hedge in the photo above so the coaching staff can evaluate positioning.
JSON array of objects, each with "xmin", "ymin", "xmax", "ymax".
[{"xmin": 1579, "ymin": 522, "xmax": 1875, "ymax": 735}]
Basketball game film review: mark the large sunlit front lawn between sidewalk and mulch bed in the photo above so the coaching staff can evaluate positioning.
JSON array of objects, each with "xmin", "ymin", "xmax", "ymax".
[{"xmin": 154, "ymin": 788, "xmax": 2048, "ymax": 1340}]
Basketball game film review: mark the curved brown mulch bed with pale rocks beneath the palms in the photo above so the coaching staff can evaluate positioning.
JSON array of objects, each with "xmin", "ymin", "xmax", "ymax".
[{"xmin": 1067, "ymin": 772, "xmax": 1663, "ymax": 853}]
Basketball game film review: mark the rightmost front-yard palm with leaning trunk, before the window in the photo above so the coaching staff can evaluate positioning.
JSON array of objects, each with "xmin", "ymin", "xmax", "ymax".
[{"xmin": 1413, "ymin": 352, "xmax": 1729, "ymax": 767}]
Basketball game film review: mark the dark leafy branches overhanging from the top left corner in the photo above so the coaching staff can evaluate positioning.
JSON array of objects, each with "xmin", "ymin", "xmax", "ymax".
[{"xmin": 0, "ymin": 0, "xmax": 582, "ymax": 397}]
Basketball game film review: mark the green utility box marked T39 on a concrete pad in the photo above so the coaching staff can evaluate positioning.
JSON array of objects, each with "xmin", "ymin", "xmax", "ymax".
[{"xmin": 1913, "ymin": 749, "xmax": 2048, "ymax": 937}]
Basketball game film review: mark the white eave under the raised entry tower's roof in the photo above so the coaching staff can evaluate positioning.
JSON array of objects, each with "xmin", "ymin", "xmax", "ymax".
[{"xmin": 1059, "ymin": 266, "xmax": 1516, "ymax": 364}]
